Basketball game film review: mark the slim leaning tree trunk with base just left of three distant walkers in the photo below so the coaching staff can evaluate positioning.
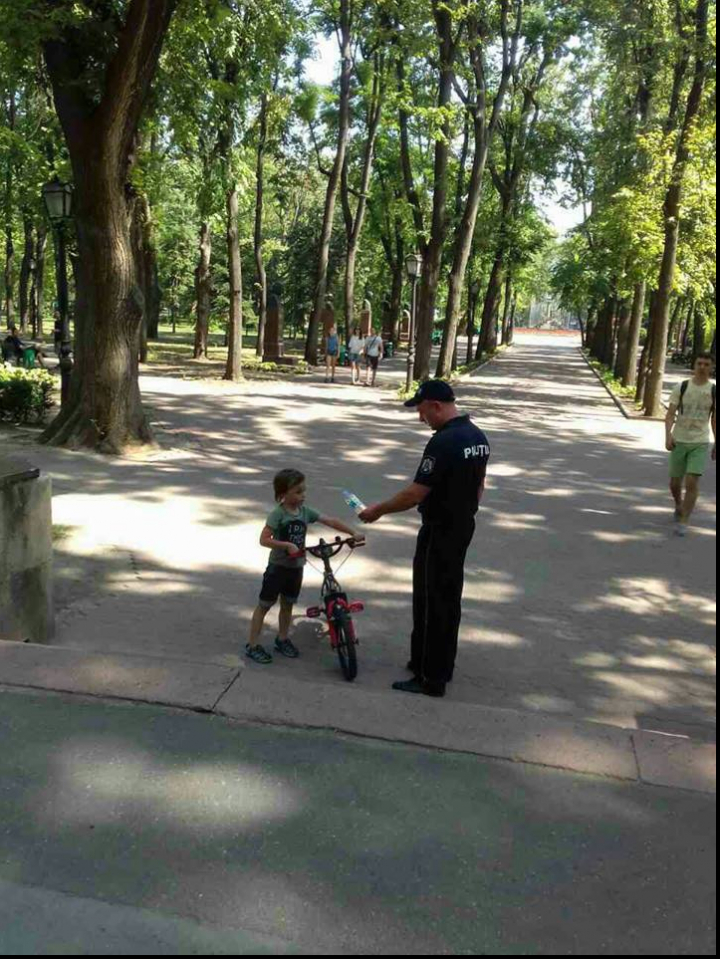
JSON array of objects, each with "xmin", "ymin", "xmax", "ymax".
[{"xmin": 305, "ymin": 0, "xmax": 353, "ymax": 366}]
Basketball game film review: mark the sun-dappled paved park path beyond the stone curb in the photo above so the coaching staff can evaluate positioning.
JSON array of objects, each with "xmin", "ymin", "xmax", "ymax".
[{"xmin": 9, "ymin": 335, "xmax": 716, "ymax": 739}]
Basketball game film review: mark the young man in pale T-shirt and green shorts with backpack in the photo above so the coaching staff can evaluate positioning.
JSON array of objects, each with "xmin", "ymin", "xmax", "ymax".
[{"xmin": 665, "ymin": 353, "xmax": 717, "ymax": 536}]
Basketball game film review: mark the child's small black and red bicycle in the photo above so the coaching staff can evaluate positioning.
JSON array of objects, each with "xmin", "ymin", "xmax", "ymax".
[{"xmin": 304, "ymin": 536, "xmax": 365, "ymax": 683}]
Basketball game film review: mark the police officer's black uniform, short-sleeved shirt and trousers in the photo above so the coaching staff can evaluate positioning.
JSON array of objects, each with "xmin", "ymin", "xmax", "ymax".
[{"xmin": 411, "ymin": 416, "xmax": 490, "ymax": 687}]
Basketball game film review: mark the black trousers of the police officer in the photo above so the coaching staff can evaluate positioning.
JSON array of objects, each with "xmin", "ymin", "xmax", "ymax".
[{"xmin": 411, "ymin": 520, "xmax": 475, "ymax": 684}]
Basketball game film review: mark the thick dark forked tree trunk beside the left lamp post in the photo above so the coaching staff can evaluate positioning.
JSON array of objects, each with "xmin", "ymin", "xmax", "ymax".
[{"xmin": 44, "ymin": 0, "xmax": 176, "ymax": 453}]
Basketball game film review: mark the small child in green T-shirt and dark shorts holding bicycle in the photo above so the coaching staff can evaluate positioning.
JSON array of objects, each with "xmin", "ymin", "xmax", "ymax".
[{"xmin": 245, "ymin": 470, "xmax": 365, "ymax": 665}]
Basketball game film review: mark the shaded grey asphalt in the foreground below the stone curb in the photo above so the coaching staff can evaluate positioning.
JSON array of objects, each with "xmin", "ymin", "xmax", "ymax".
[{"xmin": 0, "ymin": 690, "xmax": 715, "ymax": 955}]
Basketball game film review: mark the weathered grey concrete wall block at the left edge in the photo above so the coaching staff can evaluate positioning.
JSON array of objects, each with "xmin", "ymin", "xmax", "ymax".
[{"xmin": 0, "ymin": 469, "xmax": 55, "ymax": 643}]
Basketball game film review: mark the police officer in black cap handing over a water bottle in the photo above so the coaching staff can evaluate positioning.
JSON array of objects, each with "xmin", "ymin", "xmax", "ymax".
[{"xmin": 360, "ymin": 380, "xmax": 490, "ymax": 696}]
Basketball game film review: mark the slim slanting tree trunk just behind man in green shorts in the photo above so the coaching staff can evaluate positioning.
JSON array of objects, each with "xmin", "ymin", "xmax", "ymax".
[{"xmin": 644, "ymin": 0, "xmax": 709, "ymax": 416}]
